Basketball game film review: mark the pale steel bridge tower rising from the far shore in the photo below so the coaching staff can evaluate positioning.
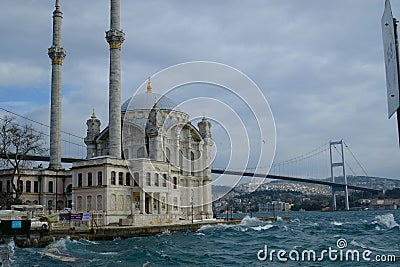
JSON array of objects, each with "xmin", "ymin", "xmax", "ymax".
[{"xmin": 329, "ymin": 140, "xmax": 350, "ymax": 213}]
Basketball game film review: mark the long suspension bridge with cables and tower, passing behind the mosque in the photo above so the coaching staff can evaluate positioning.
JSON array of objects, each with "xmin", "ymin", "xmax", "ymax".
[{"xmin": 0, "ymin": 107, "xmax": 381, "ymax": 210}]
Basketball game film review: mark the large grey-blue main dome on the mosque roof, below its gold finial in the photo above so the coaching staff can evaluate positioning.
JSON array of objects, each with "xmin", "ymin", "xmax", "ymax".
[{"xmin": 121, "ymin": 92, "xmax": 180, "ymax": 112}]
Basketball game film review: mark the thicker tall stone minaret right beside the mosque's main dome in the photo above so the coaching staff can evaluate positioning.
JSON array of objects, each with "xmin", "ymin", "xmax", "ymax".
[{"xmin": 106, "ymin": 0, "xmax": 125, "ymax": 158}]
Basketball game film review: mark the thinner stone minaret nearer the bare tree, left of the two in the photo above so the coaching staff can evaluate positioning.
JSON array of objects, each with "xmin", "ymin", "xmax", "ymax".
[{"xmin": 48, "ymin": 0, "xmax": 66, "ymax": 170}]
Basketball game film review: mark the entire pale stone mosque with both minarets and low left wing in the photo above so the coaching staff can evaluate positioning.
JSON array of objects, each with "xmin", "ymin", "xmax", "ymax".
[{"xmin": 0, "ymin": 0, "xmax": 213, "ymax": 225}]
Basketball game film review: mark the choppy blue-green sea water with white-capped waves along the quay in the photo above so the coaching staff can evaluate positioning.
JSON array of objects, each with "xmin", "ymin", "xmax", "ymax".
[{"xmin": 3, "ymin": 211, "xmax": 400, "ymax": 267}]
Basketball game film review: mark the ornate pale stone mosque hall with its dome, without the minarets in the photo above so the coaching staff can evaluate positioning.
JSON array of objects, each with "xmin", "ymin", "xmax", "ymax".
[{"xmin": 72, "ymin": 81, "xmax": 213, "ymax": 226}]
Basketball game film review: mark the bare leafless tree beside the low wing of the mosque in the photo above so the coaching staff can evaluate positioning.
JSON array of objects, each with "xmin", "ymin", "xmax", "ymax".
[{"xmin": 0, "ymin": 116, "xmax": 47, "ymax": 200}]
